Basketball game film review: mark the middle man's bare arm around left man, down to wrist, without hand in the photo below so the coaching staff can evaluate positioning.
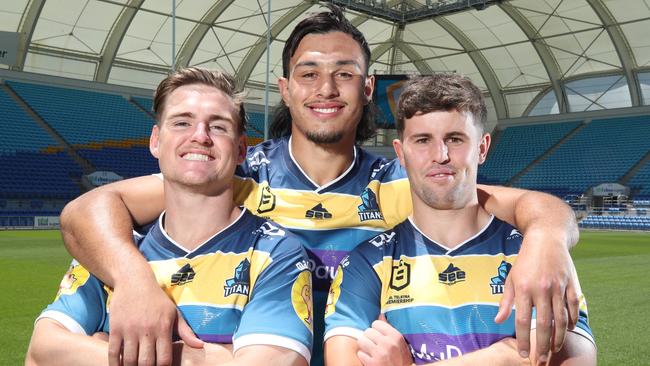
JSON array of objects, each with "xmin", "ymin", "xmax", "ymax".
[{"xmin": 61, "ymin": 177, "xmax": 163, "ymax": 286}]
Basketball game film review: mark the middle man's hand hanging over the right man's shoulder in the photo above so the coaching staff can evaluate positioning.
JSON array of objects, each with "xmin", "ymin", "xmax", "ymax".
[{"xmin": 495, "ymin": 230, "xmax": 579, "ymax": 362}]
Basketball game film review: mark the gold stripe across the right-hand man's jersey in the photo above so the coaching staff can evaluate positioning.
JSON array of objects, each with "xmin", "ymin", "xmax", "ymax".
[{"xmin": 373, "ymin": 255, "xmax": 517, "ymax": 312}]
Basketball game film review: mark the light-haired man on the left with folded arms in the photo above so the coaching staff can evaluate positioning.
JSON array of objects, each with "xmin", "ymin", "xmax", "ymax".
[{"xmin": 26, "ymin": 68, "xmax": 312, "ymax": 366}]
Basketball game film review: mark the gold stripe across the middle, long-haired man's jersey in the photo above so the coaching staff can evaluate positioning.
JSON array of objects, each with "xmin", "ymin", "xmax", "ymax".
[{"xmin": 235, "ymin": 177, "xmax": 412, "ymax": 230}]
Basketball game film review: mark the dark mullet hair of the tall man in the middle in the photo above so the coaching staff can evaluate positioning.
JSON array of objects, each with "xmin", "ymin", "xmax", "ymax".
[{"xmin": 269, "ymin": 4, "xmax": 377, "ymax": 143}]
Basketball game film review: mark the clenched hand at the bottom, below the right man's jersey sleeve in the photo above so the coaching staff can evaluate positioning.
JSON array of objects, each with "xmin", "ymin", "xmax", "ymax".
[{"xmin": 357, "ymin": 314, "xmax": 413, "ymax": 366}]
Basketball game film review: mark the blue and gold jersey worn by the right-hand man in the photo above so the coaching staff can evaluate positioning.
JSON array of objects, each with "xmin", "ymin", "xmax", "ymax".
[{"xmin": 325, "ymin": 217, "xmax": 593, "ymax": 364}]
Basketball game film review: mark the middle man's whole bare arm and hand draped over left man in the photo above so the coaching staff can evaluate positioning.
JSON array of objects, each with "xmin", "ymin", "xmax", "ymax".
[{"xmin": 61, "ymin": 176, "xmax": 202, "ymax": 366}]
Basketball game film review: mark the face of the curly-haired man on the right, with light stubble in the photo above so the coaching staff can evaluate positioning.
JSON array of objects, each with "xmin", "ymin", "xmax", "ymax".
[{"xmin": 393, "ymin": 110, "xmax": 490, "ymax": 210}]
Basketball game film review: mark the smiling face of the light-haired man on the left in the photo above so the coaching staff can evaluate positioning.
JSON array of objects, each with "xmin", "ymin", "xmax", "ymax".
[{"xmin": 149, "ymin": 84, "xmax": 246, "ymax": 192}]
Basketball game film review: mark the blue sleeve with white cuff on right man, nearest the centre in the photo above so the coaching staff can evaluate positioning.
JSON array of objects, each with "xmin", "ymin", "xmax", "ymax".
[{"xmin": 325, "ymin": 243, "xmax": 382, "ymax": 341}]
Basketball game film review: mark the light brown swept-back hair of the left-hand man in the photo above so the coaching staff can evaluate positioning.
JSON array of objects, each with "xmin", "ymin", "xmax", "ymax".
[{"xmin": 153, "ymin": 67, "xmax": 246, "ymax": 134}]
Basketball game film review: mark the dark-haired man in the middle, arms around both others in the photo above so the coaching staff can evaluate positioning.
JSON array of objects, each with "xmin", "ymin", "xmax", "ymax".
[{"xmin": 61, "ymin": 6, "xmax": 577, "ymax": 362}]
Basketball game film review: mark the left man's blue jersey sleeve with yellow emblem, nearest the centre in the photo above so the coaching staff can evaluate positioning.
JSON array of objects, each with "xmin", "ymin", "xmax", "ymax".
[{"xmin": 233, "ymin": 234, "xmax": 313, "ymax": 362}]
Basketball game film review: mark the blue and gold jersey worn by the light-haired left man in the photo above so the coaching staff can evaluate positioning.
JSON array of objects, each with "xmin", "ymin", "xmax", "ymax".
[{"xmin": 39, "ymin": 210, "xmax": 313, "ymax": 361}]
